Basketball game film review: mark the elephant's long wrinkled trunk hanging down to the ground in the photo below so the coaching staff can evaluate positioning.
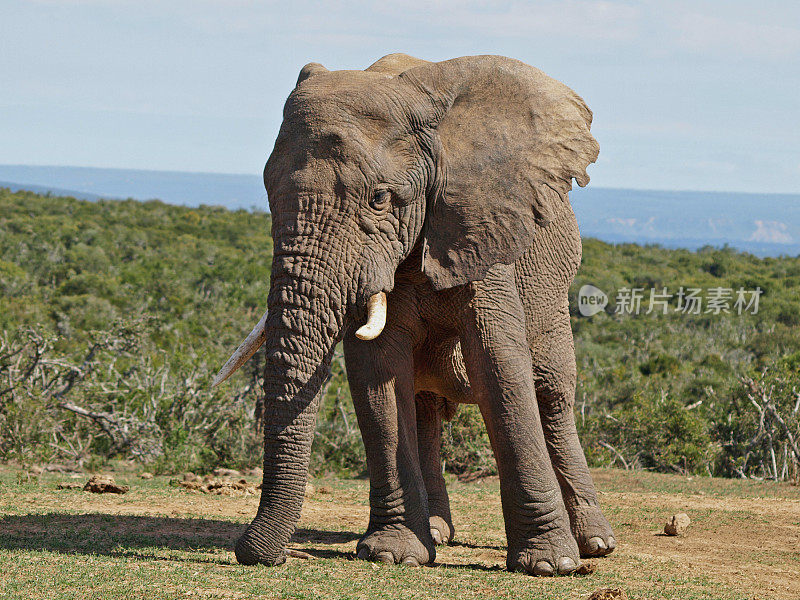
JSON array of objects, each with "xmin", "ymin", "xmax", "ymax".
[{"xmin": 236, "ymin": 256, "xmax": 344, "ymax": 565}]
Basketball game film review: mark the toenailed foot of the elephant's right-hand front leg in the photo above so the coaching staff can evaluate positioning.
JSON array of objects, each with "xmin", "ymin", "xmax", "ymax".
[{"xmin": 506, "ymin": 527, "xmax": 581, "ymax": 577}]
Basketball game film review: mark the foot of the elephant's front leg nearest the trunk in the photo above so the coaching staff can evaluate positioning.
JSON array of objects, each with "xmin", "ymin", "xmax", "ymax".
[{"xmin": 356, "ymin": 525, "xmax": 436, "ymax": 567}]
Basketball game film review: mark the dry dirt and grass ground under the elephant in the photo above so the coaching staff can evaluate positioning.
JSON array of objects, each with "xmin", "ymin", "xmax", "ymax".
[{"xmin": 0, "ymin": 469, "xmax": 800, "ymax": 600}]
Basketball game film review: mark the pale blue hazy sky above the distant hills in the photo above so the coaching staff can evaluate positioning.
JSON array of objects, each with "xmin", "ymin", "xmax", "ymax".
[{"xmin": 0, "ymin": 0, "xmax": 800, "ymax": 193}]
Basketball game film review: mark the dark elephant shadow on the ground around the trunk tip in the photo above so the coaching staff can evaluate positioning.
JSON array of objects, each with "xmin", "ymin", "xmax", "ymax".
[{"xmin": 0, "ymin": 512, "xmax": 360, "ymax": 564}]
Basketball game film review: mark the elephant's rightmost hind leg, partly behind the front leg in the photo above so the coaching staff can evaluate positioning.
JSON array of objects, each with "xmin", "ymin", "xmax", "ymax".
[{"xmin": 533, "ymin": 310, "xmax": 616, "ymax": 558}]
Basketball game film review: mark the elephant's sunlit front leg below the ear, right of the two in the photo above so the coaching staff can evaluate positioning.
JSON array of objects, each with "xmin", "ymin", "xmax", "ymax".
[{"xmin": 460, "ymin": 265, "xmax": 580, "ymax": 575}]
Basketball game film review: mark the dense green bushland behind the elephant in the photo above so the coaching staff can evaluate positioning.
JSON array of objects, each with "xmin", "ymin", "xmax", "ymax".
[{"xmin": 0, "ymin": 190, "xmax": 800, "ymax": 479}]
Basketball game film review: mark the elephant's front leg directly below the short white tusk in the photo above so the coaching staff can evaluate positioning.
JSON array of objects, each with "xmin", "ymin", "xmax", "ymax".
[{"xmin": 344, "ymin": 326, "xmax": 436, "ymax": 565}]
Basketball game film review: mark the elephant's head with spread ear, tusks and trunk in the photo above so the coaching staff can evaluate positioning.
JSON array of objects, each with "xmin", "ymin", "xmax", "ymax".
[{"xmin": 215, "ymin": 55, "xmax": 598, "ymax": 564}]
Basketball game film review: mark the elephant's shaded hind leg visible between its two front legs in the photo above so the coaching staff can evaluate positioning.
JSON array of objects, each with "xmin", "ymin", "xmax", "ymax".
[{"xmin": 416, "ymin": 392, "xmax": 455, "ymax": 544}]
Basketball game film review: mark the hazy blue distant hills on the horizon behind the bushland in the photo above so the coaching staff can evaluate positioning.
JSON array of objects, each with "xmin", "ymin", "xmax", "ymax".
[{"xmin": 0, "ymin": 165, "xmax": 800, "ymax": 256}]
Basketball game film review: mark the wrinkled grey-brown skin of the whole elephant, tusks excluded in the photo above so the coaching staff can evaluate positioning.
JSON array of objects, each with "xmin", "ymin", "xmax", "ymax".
[{"xmin": 236, "ymin": 55, "xmax": 614, "ymax": 575}]
